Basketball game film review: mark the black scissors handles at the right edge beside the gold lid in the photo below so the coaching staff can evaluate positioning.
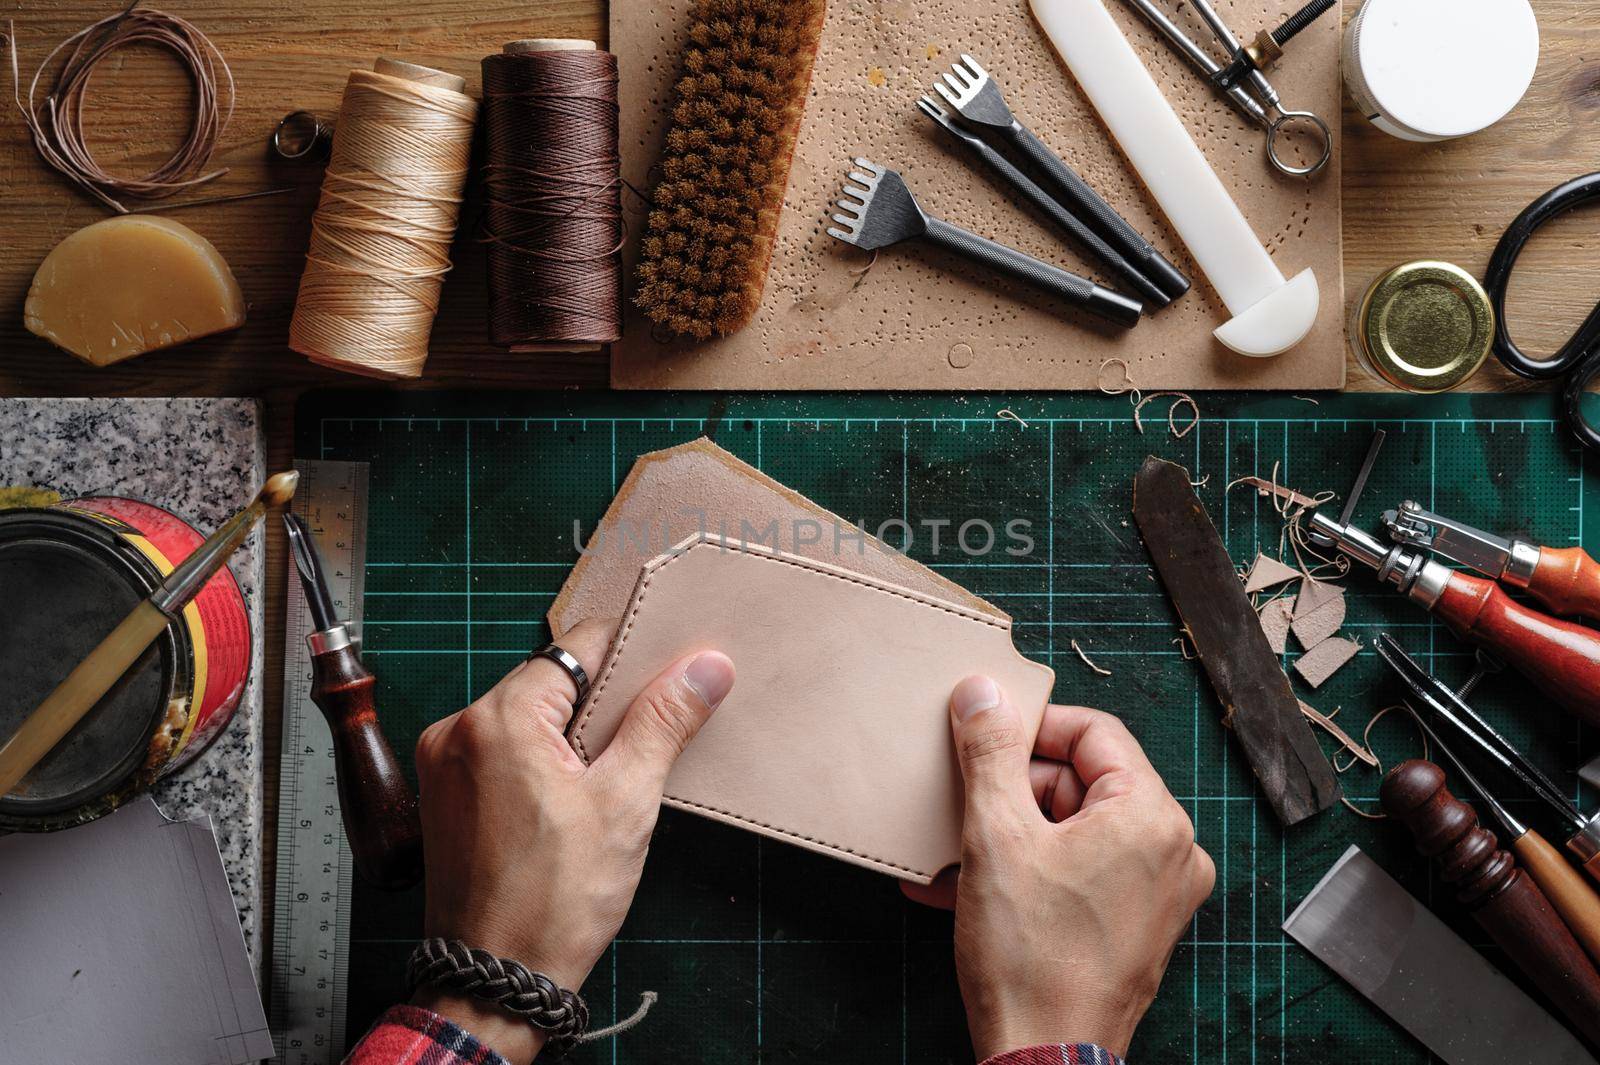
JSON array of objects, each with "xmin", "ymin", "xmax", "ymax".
[{"xmin": 1483, "ymin": 173, "xmax": 1600, "ymax": 451}]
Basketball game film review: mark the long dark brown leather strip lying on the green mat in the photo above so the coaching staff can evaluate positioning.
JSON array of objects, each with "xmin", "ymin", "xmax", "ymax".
[{"xmin": 1133, "ymin": 457, "xmax": 1341, "ymax": 825}]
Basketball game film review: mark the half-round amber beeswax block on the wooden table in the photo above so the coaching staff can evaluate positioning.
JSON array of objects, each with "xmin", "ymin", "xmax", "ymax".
[{"xmin": 22, "ymin": 214, "xmax": 245, "ymax": 366}]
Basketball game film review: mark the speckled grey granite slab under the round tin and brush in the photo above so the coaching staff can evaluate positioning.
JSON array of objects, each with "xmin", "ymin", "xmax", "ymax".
[{"xmin": 0, "ymin": 398, "xmax": 266, "ymax": 964}]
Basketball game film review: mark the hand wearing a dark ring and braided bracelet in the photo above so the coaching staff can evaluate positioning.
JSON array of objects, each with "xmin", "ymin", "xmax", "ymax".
[{"xmin": 413, "ymin": 622, "xmax": 733, "ymax": 1062}]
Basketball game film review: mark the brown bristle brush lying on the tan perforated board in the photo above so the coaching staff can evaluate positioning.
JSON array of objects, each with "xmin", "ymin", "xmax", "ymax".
[{"xmin": 635, "ymin": 0, "xmax": 826, "ymax": 339}]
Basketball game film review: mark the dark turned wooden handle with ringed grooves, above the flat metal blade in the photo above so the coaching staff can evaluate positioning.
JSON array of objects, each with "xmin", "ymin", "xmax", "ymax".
[{"xmin": 1379, "ymin": 760, "xmax": 1600, "ymax": 1047}]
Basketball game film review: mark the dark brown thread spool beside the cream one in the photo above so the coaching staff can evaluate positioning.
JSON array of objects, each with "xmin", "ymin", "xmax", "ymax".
[{"xmin": 483, "ymin": 38, "xmax": 622, "ymax": 352}]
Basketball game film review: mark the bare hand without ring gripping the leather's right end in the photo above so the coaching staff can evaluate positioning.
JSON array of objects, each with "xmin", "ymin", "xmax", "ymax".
[{"xmin": 904, "ymin": 676, "xmax": 1216, "ymax": 1060}]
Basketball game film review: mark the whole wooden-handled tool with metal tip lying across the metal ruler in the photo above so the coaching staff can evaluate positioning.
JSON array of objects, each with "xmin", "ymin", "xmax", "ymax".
[{"xmin": 283, "ymin": 513, "xmax": 422, "ymax": 891}]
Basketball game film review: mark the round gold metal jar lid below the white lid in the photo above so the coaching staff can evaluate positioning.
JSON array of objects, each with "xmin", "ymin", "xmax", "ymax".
[{"xmin": 1352, "ymin": 261, "xmax": 1494, "ymax": 392}]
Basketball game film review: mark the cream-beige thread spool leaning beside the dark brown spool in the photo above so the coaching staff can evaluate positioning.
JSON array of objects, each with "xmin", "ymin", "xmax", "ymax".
[{"xmin": 290, "ymin": 59, "xmax": 478, "ymax": 377}]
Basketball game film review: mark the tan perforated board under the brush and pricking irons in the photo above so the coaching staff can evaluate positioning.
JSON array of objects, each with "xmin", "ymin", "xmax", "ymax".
[{"xmin": 611, "ymin": 0, "xmax": 1344, "ymax": 390}]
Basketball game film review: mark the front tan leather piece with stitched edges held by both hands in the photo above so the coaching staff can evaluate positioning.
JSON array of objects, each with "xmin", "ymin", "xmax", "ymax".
[{"xmin": 568, "ymin": 536, "xmax": 1054, "ymax": 883}]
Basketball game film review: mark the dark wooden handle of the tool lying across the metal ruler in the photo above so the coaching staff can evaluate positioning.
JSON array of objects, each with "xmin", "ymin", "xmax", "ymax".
[{"xmin": 310, "ymin": 648, "xmax": 422, "ymax": 891}]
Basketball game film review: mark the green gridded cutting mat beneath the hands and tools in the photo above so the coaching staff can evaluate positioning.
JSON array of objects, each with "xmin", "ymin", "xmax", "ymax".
[{"xmin": 298, "ymin": 393, "xmax": 1600, "ymax": 1065}]
